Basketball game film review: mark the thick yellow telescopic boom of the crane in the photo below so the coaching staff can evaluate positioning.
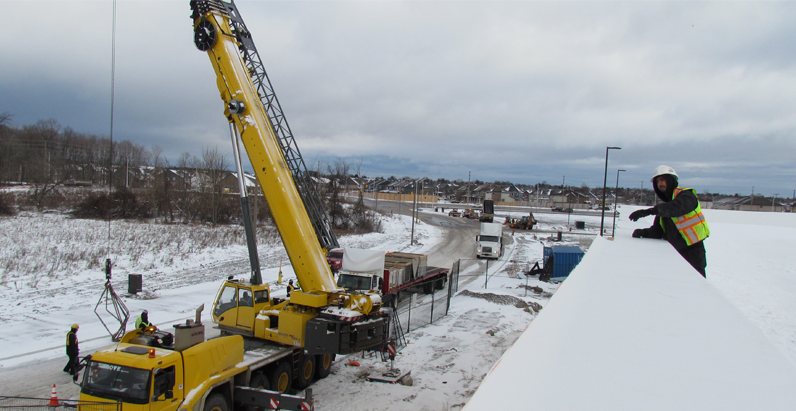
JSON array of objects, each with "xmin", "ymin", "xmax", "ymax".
[{"xmin": 191, "ymin": 0, "xmax": 337, "ymax": 293}]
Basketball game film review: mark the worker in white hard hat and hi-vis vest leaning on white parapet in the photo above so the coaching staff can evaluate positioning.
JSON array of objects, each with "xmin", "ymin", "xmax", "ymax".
[{"xmin": 630, "ymin": 165, "xmax": 710, "ymax": 277}]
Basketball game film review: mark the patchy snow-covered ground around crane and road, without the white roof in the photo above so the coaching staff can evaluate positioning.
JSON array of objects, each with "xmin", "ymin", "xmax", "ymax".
[{"xmin": 0, "ymin": 210, "xmax": 580, "ymax": 410}]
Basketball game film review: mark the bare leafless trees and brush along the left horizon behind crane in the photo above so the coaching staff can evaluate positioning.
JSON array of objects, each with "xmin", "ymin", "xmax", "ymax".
[{"xmin": 0, "ymin": 113, "xmax": 380, "ymax": 232}]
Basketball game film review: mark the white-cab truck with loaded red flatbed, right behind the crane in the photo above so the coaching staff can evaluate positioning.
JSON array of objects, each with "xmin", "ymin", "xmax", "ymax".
[{"xmin": 337, "ymin": 248, "xmax": 450, "ymax": 297}]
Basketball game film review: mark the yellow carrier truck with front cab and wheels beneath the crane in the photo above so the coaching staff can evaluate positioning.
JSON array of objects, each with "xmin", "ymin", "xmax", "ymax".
[{"xmin": 80, "ymin": 307, "xmax": 316, "ymax": 411}]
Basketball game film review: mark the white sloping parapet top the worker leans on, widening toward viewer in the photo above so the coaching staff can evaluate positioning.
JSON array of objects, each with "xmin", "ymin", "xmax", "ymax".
[{"xmin": 465, "ymin": 233, "xmax": 796, "ymax": 411}]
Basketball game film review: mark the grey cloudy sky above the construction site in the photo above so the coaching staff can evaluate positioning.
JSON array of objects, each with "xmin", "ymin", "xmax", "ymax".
[{"xmin": 0, "ymin": 0, "xmax": 796, "ymax": 197}]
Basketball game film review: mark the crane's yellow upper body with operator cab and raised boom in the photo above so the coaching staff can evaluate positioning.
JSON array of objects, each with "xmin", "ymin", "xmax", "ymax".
[{"xmin": 191, "ymin": 0, "xmax": 388, "ymax": 369}]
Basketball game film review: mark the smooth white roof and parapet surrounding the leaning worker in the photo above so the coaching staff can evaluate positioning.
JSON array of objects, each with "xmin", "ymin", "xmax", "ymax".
[{"xmin": 465, "ymin": 211, "xmax": 796, "ymax": 411}]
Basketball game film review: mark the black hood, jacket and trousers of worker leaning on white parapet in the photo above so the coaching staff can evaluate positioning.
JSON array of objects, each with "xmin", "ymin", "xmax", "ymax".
[{"xmin": 637, "ymin": 175, "xmax": 707, "ymax": 276}]
